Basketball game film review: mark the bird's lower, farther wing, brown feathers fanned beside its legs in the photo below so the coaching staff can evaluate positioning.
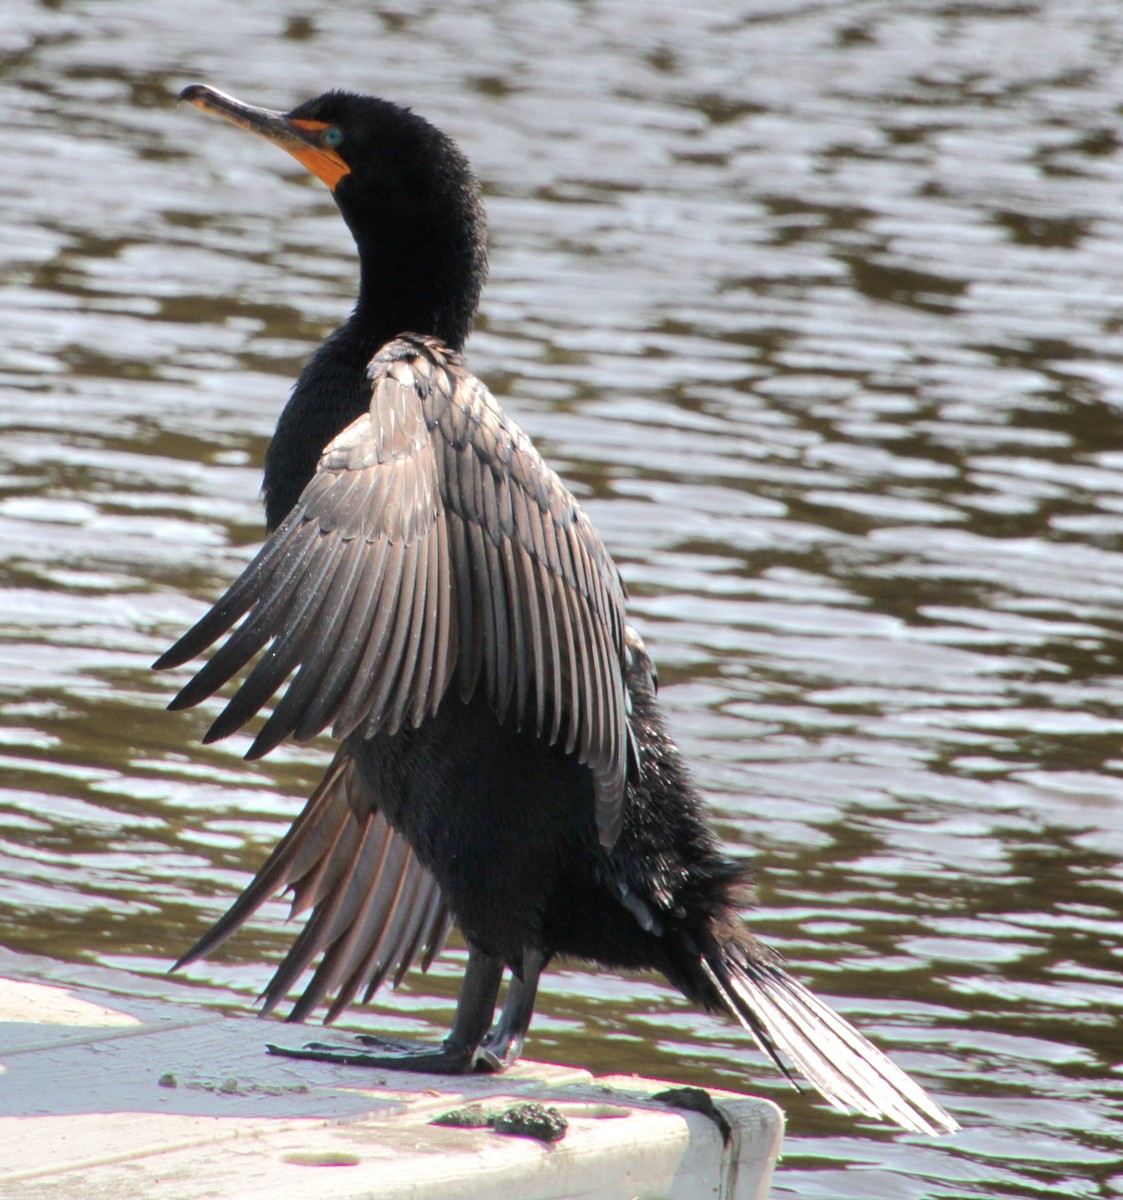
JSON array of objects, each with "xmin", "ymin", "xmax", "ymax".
[{"xmin": 173, "ymin": 746, "xmax": 452, "ymax": 1021}]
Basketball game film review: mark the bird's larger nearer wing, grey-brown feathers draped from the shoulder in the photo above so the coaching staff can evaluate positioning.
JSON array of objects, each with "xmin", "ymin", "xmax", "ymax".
[{"xmin": 156, "ymin": 335, "xmax": 635, "ymax": 845}]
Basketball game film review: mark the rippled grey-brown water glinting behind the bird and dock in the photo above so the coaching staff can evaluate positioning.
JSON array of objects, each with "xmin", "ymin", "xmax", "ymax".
[{"xmin": 0, "ymin": 0, "xmax": 1123, "ymax": 1200}]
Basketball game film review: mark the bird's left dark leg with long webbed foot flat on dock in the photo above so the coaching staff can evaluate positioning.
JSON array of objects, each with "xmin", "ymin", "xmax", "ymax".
[{"xmin": 268, "ymin": 946, "xmax": 501, "ymax": 1075}]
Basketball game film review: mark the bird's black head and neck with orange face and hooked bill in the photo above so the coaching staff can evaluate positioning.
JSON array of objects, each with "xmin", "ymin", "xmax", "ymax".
[{"xmin": 180, "ymin": 84, "xmax": 487, "ymax": 349}]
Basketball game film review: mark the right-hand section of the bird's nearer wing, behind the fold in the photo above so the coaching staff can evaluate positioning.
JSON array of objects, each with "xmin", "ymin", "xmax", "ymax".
[{"xmin": 417, "ymin": 338, "xmax": 635, "ymax": 845}]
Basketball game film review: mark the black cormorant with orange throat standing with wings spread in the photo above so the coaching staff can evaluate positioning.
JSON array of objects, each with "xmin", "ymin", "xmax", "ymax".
[{"xmin": 156, "ymin": 84, "xmax": 956, "ymax": 1133}]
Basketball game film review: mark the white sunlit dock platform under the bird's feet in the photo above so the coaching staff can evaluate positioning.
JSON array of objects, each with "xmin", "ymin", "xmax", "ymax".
[{"xmin": 0, "ymin": 949, "xmax": 783, "ymax": 1200}]
